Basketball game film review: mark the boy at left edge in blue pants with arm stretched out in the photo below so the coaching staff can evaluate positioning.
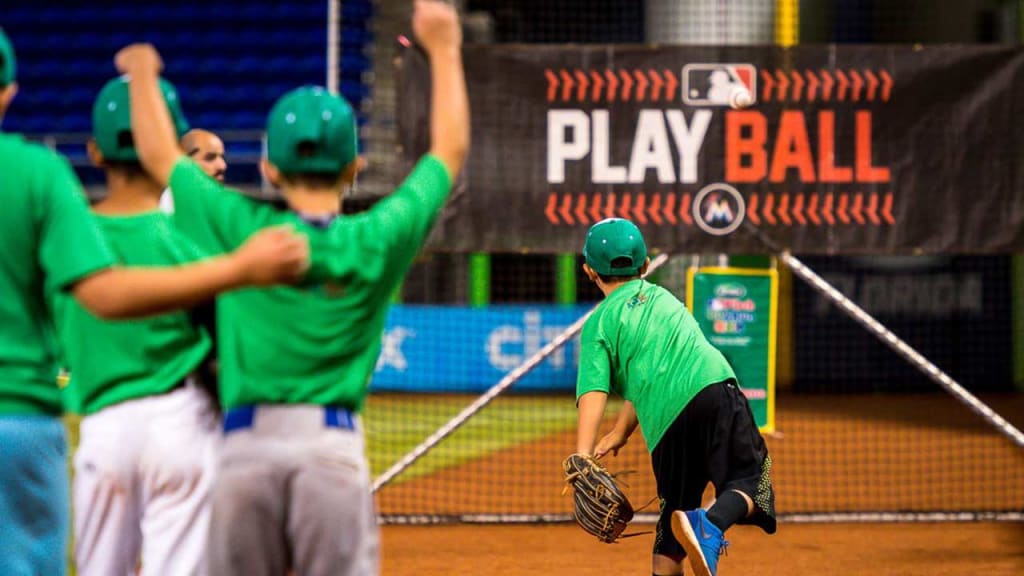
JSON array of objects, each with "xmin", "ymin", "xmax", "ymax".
[{"xmin": 0, "ymin": 25, "xmax": 307, "ymax": 576}]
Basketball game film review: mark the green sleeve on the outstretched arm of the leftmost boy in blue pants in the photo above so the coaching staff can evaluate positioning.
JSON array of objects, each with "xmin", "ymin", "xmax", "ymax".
[{"xmin": 38, "ymin": 158, "xmax": 115, "ymax": 290}]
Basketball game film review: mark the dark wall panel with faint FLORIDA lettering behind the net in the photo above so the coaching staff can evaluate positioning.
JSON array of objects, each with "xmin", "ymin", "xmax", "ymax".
[{"xmin": 792, "ymin": 255, "xmax": 1015, "ymax": 394}]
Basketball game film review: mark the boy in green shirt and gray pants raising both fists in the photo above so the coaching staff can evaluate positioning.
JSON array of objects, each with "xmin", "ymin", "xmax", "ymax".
[{"xmin": 117, "ymin": 0, "xmax": 469, "ymax": 576}]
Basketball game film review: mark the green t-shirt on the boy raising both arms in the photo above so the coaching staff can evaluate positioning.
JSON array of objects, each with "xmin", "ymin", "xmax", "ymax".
[{"xmin": 171, "ymin": 156, "xmax": 452, "ymax": 410}]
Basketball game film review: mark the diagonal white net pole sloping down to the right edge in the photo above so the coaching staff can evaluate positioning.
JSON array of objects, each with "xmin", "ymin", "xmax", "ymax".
[{"xmin": 779, "ymin": 250, "xmax": 1024, "ymax": 448}]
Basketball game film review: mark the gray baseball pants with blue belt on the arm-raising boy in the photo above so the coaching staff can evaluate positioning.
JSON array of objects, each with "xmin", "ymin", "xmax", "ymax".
[{"xmin": 208, "ymin": 405, "xmax": 379, "ymax": 576}]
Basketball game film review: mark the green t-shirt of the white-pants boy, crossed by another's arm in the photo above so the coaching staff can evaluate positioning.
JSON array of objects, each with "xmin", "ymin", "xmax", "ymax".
[{"xmin": 54, "ymin": 211, "xmax": 210, "ymax": 414}]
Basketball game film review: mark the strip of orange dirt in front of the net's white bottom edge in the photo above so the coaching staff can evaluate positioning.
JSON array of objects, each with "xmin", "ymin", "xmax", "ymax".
[{"xmin": 382, "ymin": 523, "xmax": 1024, "ymax": 576}]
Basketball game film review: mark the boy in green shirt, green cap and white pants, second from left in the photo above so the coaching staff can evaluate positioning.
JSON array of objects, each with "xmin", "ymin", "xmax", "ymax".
[{"xmin": 55, "ymin": 78, "xmax": 305, "ymax": 576}]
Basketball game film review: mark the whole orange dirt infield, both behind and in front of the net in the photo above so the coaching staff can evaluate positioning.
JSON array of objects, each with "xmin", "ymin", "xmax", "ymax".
[{"xmin": 379, "ymin": 395, "xmax": 1024, "ymax": 576}]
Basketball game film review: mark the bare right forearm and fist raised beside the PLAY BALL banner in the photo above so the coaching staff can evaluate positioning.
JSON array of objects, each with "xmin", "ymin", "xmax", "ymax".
[{"xmin": 413, "ymin": 0, "xmax": 469, "ymax": 178}]
